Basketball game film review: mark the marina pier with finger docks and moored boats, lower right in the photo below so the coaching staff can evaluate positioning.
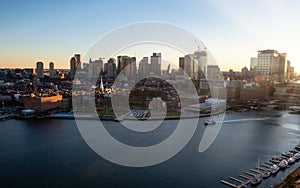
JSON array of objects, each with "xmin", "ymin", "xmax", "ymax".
[{"xmin": 220, "ymin": 145, "xmax": 300, "ymax": 188}]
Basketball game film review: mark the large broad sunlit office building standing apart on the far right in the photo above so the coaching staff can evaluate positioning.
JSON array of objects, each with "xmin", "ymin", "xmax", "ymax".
[{"xmin": 255, "ymin": 50, "xmax": 287, "ymax": 82}]
